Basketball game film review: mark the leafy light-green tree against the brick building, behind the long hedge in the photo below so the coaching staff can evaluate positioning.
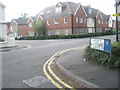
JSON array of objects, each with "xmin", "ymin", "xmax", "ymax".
[{"xmin": 33, "ymin": 20, "xmax": 45, "ymax": 36}]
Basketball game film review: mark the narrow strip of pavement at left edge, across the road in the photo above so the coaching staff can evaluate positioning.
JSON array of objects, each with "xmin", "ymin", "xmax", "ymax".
[{"xmin": 0, "ymin": 44, "xmax": 28, "ymax": 52}]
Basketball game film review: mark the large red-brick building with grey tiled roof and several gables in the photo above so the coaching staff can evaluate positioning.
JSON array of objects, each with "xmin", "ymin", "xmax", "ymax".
[{"xmin": 32, "ymin": 2, "xmax": 112, "ymax": 35}]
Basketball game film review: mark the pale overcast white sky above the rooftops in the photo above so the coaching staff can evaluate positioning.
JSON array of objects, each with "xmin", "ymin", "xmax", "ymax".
[{"xmin": 0, "ymin": 0, "xmax": 115, "ymax": 21}]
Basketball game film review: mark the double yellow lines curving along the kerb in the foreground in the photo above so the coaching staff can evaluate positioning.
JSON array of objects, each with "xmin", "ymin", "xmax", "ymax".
[{"xmin": 43, "ymin": 52, "xmax": 74, "ymax": 90}]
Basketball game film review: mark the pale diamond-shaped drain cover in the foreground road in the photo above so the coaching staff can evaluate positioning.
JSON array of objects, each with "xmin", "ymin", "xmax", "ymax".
[{"xmin": 23, "ymin": 76, "xmax": 50, "ymax": 87}]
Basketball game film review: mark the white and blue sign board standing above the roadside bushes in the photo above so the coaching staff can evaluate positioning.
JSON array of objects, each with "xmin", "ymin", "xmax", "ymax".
[{"xmin": 90, "ymin": 38, "xmax": 111, "ymax": 53}]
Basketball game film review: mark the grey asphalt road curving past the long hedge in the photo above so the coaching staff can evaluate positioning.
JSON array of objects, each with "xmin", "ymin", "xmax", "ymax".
[{"xmin": 2, "ymin": 35, "xmax": 115, "ymax": 88}]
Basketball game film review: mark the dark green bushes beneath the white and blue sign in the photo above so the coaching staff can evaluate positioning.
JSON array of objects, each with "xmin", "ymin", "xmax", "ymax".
[{"xmin": 85, "ymin": 42, "xmax": 120, "ymax": 68}]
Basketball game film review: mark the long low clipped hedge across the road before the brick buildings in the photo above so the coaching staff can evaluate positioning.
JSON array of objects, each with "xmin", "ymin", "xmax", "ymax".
[{"xmin": 16, "ymin": 31, "xmax": 115, "ymax": 40}]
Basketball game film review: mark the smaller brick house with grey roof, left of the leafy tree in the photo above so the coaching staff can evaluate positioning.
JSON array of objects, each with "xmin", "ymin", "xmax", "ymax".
[{"xmin": 8, "ymin": 19, "xmax": 34, "ymax": 37}]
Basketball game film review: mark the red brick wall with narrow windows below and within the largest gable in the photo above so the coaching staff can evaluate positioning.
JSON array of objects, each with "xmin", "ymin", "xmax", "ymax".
[{"xmin": 73, "ymin": 6, "xmax": 87, "ymax": 28}]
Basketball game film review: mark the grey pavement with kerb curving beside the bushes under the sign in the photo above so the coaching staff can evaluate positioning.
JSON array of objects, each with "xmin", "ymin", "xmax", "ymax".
[{"xmin": 56, "ymin": 47, "xmax": 118, "ymax": 88}]
